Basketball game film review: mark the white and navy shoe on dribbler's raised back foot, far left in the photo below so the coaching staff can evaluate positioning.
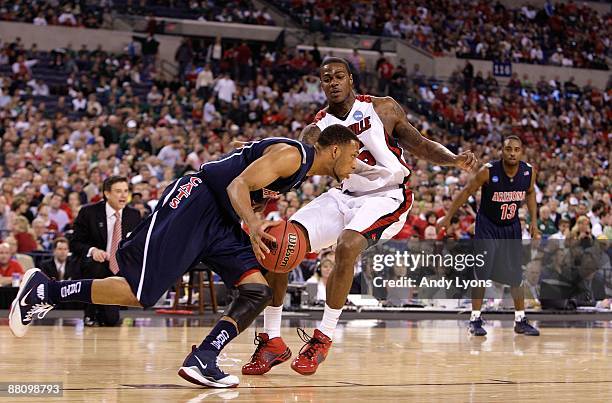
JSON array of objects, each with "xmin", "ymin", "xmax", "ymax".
[{"xmin": 9, "ymin": 268, "xmax": 55, "ymax": 337}]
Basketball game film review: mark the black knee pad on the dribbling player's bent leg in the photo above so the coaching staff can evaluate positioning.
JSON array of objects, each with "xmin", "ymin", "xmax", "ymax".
[{"xmin": 226, "ymin": 283, "xmax": 272, "ymax": 332}]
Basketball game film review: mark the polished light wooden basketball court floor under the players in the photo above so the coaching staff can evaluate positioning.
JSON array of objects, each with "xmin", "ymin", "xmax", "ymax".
[{"xmin": 0, "ymin": 319, "xmax": 612, "ymax": 403}]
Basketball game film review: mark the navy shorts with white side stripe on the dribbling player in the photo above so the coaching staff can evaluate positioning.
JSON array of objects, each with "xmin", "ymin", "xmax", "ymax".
[{"xmin": 117, "ymin": 173, "xmax": 261, "ymax": 307}]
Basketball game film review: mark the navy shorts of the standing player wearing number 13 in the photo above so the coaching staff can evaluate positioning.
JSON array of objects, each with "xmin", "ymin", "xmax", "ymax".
[{"xmin": 474, "ymin": 214, "xmax": 523, "ymax": 287}]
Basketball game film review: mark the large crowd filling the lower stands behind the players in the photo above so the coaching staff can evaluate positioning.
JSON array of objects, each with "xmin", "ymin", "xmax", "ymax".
[{"xmin": 0, "ymin": 33, "xmax": 612, "ymax": 308}]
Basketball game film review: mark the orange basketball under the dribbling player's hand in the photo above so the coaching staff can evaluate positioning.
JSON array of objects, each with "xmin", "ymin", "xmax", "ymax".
[{"xmin": 261, "ymin": 221, "xmax": 308, "ymax": 273}]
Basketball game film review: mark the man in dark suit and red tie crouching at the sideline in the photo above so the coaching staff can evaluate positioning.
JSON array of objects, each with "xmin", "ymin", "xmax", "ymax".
[{"xmin": 71, "ymin": 176, "xmax": 141, "ymax": 326}]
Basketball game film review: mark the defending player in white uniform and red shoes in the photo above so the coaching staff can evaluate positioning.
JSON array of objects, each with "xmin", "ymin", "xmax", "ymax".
[{"xmin": 242, "ymin": 58, "xmax": 477, "ymax": 375}]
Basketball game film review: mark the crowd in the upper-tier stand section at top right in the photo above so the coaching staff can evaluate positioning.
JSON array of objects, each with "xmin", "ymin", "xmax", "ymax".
[{"xmin": 279, "ymin": 0, "xmax": 612, "ymax": 70}]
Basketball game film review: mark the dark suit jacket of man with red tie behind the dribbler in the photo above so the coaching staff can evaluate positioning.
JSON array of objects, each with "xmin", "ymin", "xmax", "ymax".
[{"xmin": 70, "ymin": 200, "xmax": 141, "ymax": 278}]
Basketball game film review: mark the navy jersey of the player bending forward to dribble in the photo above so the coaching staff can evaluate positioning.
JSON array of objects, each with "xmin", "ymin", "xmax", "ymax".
[{"xmin": 200, "ymin": 137, "xmax": 315, "ymax": 221}]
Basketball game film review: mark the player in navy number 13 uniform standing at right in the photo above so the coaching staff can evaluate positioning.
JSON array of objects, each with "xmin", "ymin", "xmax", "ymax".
[{"xmin": 439, "ymin": 136, "xmax": 540, "ymax": 336}]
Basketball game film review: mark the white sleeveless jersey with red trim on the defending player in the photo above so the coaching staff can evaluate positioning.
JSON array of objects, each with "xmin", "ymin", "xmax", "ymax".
[{"xmin": 314, "ymin": 95, "xmax": 410, "ymax": 192}]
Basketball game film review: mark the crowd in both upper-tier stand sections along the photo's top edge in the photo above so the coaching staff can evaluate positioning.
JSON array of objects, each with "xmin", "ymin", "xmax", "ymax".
[{"xmin": 0, "ymin": 0, "xmax": 612, "ymax": 70}]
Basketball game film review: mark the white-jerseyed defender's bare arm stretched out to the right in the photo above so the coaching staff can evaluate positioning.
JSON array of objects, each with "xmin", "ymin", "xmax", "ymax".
[{"xmin": 377, "ymin": 97, "xmax": 478, "ymax": 171}]
